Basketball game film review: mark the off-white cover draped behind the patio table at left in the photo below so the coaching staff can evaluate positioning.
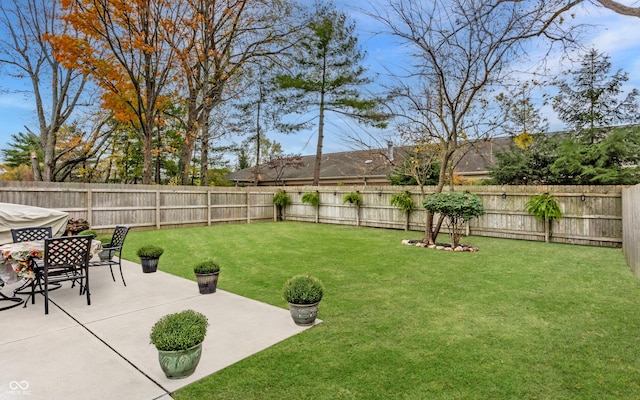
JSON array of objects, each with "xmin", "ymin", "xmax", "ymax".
[{"xmin": 0, "ymin": 203, "xmax": 69, "ymax": 244}]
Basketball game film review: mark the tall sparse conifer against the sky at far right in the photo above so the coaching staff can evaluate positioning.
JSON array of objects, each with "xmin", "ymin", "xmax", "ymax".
[{"xmin": 553, "ymin": 49, "xmax": 640, "ymax": 144}]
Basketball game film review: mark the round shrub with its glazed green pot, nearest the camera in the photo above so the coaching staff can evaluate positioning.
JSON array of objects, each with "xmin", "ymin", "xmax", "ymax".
[{"xmin": 150, "ymin": 310, "xmax": 209, "ymax": 379}]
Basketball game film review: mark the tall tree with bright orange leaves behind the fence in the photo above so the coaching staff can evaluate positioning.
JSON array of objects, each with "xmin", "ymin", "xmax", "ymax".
[{"xmin": 45, "ymin": 0, "xmax": 178, "ymax": 184}]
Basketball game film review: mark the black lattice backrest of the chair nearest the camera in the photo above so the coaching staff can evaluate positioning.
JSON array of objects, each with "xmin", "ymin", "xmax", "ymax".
[{"xmin": 43, "ymin": 235, "xmax": 93, "ymax": 271}]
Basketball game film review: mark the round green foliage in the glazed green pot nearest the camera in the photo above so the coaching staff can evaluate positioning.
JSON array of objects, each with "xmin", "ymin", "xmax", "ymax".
[{"xmin": 150, "ymin": 310, "xmax": 209, "ymax": 351}]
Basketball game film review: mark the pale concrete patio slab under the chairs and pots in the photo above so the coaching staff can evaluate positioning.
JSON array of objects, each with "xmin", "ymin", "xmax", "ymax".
[{"xmin": 0, "ymin": 260, "xmax": 320, "ymax": 400}]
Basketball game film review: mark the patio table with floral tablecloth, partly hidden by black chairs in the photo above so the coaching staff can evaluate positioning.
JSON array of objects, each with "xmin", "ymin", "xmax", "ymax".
[{"xmin": 0, "ymin": 240, "xmax": 102, "ymax": 310}]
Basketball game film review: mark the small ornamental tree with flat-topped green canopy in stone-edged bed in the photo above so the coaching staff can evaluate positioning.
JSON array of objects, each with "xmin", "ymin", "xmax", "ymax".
[{"xmin": 422, "ymin": 192, "xmax": 484, "ymax": 248}]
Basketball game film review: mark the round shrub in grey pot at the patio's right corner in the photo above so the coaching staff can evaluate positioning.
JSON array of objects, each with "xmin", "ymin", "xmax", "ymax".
[{"xmin": 282, "ymin": 274, "xmax": 324, "ymax": 326}]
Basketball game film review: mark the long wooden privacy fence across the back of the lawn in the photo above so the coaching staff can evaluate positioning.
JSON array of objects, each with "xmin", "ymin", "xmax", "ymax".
[{"xmin": 0, "ymin": 181, "xmax": 622, "ymax": 247}]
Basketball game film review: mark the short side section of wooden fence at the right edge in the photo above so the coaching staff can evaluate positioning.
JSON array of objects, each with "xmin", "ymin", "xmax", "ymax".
[{"xmin": 622, "ymin": 185, "xmax": 640, "ymax": 278}]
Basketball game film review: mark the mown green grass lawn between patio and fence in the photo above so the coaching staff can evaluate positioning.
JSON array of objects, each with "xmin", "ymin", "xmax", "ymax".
[{"xmin": 125, "ymin": 222, "xmax": 640, "ymax": 400}]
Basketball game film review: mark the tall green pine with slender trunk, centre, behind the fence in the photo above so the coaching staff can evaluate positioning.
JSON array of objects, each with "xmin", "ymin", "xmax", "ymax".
[{"xmin": 276, "ymin": 4, "xmax": 386, "ymax": 185}]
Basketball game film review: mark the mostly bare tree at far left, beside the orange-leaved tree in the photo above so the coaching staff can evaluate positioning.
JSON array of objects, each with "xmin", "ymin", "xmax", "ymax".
[{"xmin": 0, "ymin": 0, "xmax": 98, "ymax": 182}]
